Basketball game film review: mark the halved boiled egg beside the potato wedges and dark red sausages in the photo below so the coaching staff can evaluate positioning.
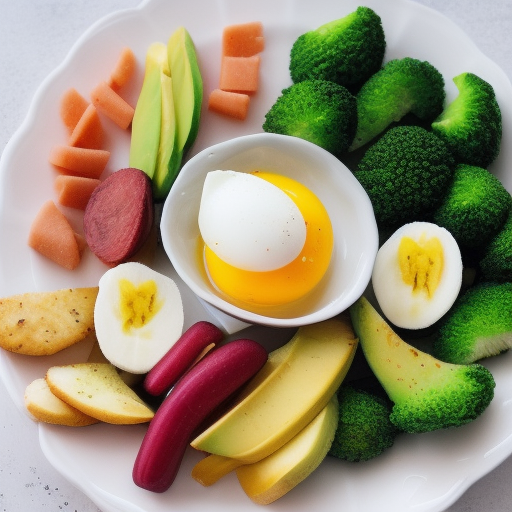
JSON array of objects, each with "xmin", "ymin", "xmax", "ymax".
[{"xmin": 94, "ymin": 262, "xmax": 184, "ymax": 374}]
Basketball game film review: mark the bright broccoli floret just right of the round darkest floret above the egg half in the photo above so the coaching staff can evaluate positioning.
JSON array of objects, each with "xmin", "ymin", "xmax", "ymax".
[{"xmin": 433, "ymin": 164, "xmax": 512, "ymax": 249}]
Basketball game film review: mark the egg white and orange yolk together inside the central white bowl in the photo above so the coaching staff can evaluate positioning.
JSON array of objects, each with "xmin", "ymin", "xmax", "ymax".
[{"xmin": 198, "ymin": 171, "xmax": 333, "ymax": 309}]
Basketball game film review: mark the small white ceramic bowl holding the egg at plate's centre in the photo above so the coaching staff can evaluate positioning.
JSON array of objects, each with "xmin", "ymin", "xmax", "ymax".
[{"xmin": 161, "ymin": 133, "xmax": 378, "ymax": 327}]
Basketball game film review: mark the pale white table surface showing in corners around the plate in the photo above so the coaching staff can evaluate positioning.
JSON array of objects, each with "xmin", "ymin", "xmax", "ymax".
[{"xmin": 0, "ymin": 0, "xmax": 512, "ymax": 512}]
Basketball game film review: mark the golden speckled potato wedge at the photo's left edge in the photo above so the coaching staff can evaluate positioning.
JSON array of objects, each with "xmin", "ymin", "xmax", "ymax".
[{"xmin": 0, "ymin": 287, "xmax": 98, "ymax": 356}]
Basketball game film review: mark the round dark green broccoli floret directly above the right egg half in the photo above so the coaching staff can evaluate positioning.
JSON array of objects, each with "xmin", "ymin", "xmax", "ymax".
[{"xmin": 354, "ymin": 126, "xmax": 455, "ymax": 229}]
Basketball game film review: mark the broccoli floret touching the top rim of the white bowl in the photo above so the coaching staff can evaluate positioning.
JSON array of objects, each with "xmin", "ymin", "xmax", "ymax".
[{"xmin": 263, "ymin": 80, "xmax": 357, "ymax": 156}]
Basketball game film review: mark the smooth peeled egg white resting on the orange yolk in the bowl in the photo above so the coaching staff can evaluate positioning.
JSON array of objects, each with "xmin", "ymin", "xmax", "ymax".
[{"xmin": 198, "ymin": 171, "xmax": 306, "ymax": 272}]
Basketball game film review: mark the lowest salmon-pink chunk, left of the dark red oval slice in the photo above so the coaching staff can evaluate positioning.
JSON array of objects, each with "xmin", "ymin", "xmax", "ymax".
[{"xmin": 28, "ymin": 200, "xmax": 84, "ymax": 270}]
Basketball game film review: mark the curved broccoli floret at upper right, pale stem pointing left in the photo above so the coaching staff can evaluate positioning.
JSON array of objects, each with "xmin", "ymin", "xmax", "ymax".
[{"xmin": 432, "ymin": 73, "xmax": 502, "ymax": 167}]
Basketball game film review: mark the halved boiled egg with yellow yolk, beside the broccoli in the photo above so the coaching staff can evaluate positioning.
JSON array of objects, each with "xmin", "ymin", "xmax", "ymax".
[{"xmin": 372, "ymin": 222, "xmax": 462, "ymax": 329}]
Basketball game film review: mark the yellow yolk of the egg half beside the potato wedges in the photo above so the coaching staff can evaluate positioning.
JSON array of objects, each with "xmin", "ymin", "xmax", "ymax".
[{"xmin": 119, "ymin": 279, "xmax": 161, "ymax": 332}]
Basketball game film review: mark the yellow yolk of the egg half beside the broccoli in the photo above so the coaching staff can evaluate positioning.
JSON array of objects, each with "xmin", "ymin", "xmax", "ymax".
[{"xmin": 398, "ymin": 236, "xmax": 444, "ymax": 298}]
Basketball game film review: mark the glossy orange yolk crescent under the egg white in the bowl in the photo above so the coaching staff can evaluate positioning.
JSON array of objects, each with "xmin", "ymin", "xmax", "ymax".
[{"xmin": 204, "ymin": 171, "xmax": 333, "ymax": 307}]
